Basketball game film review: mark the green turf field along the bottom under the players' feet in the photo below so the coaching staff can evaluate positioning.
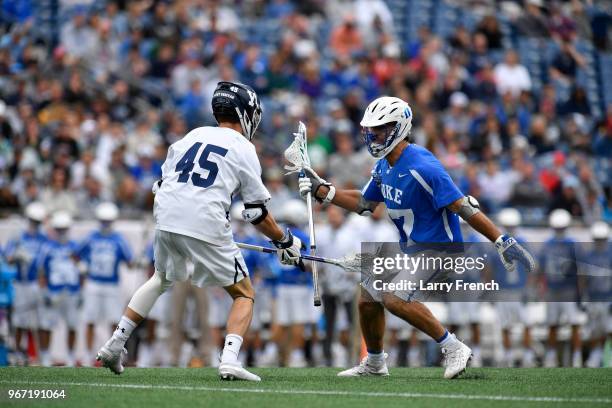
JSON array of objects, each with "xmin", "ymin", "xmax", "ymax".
[{"xmin": 0, "ymin": 367, "xmax": 612, "ymax": 408}]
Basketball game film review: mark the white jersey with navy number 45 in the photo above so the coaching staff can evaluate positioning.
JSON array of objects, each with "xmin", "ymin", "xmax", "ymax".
[{"xmin": 153, "ymin": 127, "xmax": 270, "ymax": 245}]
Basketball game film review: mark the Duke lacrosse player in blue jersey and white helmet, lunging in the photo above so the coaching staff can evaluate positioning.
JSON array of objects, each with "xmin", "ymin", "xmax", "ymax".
[{"xmin": 299, "ymin": 96, "xmax": 535, "ymax": 378}]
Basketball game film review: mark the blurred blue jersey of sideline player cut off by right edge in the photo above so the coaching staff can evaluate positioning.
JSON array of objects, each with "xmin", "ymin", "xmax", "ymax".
[{"xmin": 580, "ymin": 243, "xmax": 612, "ymax": 302}]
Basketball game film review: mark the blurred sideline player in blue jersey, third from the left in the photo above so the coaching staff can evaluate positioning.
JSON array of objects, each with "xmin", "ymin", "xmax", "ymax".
[{"xmin": 77, "ymin": 202, "xmax": 132, "ymax": 365}]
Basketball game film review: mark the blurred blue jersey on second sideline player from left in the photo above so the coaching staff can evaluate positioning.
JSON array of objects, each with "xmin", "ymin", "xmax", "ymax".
[{"xmin": 39, "ymin": 240, "xmax": 81, "ymax": 293}]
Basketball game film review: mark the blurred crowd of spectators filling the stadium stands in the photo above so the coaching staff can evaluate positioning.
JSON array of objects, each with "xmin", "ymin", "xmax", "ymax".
[{"xmin": 0, "ymin": 0, "xmax": 612, "ymax": 224}]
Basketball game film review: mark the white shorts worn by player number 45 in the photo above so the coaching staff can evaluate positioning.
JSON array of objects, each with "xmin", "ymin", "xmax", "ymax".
[{"xmin": 154, "ymin": 230, "xmax": 249, "ymax": 287}]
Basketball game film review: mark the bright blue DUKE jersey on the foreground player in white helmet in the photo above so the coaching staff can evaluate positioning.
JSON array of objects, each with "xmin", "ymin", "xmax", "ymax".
[{"xmin": 361, "ymin": 144, "xmax": 463, "ymax": 243}]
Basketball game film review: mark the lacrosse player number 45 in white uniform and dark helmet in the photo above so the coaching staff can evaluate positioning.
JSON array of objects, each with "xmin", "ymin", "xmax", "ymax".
[{"xmin": 97, "ymin": 82, "xmax": 302, "ymax": 381}]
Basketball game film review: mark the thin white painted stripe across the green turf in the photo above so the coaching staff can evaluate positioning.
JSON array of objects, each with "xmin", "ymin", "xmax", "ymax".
[{"xmin": 0, "ymin": 380, "xmax": 612, "ymax": 404}]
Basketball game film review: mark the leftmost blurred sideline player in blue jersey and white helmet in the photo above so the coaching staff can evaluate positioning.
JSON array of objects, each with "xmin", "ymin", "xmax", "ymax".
[{"xmin": 4, "ymin": 202, "xmax": 47, "ymax": 362}]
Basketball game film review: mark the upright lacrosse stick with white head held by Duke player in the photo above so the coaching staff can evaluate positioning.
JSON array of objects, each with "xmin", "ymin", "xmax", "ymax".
[{"xmin": 285, "ymin": 121, "xmax": 321, "ymax": 306}]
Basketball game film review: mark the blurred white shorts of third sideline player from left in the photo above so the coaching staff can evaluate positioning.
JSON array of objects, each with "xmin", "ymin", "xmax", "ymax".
[{"xmin": 83, "ymin": 280, "xmax": 125, "ymax": 324}]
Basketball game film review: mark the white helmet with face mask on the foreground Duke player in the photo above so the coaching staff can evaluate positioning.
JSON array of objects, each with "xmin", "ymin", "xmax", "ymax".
[{"xmin": 360, "ymin": 96, "xmax": 412, "ymax": 159}]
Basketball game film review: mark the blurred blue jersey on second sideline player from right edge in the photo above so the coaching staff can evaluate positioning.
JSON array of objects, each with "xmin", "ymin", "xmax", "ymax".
[{"xmin": 540, "ymin": 237, "xmax": 578, "ymax": 290}]
